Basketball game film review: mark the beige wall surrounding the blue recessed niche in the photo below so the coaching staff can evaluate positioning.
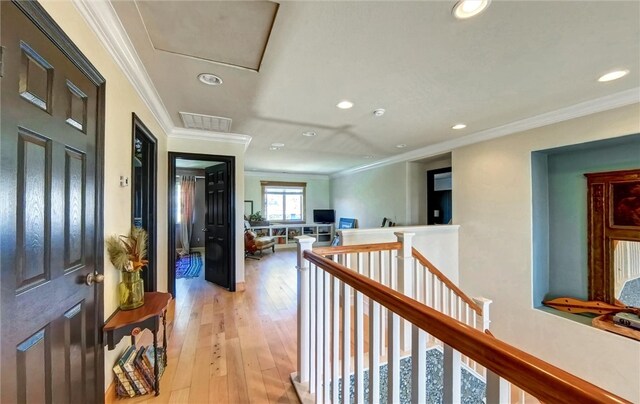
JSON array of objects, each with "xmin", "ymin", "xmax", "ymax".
[{"xmin": 453, "ymin": 104, "xmax": 640, "ymax": 402}]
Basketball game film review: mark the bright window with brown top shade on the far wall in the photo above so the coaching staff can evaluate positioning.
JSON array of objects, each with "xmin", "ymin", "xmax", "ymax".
[{"xmin": 261, "ymin": 181, "xmax": 307, "ymax": 223}]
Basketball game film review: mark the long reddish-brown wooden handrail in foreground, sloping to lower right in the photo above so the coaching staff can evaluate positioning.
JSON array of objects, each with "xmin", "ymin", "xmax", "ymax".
[{"xmin": 304, "ymin": 251, "xmax": 630, "ymax": 403}]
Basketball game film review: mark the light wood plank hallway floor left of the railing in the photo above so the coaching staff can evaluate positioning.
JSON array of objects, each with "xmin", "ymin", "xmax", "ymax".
[{"xmin": 132, "ymin": 249, "xmax": 299, "ymax": 404}]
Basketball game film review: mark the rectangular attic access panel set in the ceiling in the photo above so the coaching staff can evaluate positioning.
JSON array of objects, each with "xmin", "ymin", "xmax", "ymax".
[{"xmin": 136, "ymin": 1, "xmax": 278, "ymax": 71}]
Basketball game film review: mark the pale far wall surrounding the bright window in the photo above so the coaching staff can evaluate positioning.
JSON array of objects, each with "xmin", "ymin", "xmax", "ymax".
[{"xmin": 244, "ymin": 173, "xmax": 331, "ymax": 223}]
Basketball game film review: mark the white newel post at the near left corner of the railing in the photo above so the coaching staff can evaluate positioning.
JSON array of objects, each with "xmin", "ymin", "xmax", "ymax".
[{"xmin": 296, "ymin": 236, "xmax": 316, "ymax": 383}]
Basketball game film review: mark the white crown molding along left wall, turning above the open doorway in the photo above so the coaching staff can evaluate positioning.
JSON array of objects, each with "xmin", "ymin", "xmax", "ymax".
[{"xmin": 72, "ymin": 0, "xmax": 251, "ymax": 150}]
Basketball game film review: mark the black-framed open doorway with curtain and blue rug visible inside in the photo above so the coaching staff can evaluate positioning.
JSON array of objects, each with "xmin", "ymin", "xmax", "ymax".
[{"xmin": 167, "ymin": 152, "xmax": 236, "ymax": 296}]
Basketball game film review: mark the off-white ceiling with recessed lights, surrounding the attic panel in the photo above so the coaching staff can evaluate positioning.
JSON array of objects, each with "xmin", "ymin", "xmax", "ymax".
[{"xmin": 112, "ymin": 1, "xmax": 640, "ymax": 174}]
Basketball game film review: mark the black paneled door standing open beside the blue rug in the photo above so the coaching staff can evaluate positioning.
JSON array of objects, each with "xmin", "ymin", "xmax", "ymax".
[{"xmin": 204, "ymin": 163, "xmax": 236, "ymax": 291}]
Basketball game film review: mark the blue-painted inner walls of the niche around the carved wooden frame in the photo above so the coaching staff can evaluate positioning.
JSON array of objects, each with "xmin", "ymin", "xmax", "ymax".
[{"xmin": 531, "ymin": 134, "xmax": 640, "ymax": 306}]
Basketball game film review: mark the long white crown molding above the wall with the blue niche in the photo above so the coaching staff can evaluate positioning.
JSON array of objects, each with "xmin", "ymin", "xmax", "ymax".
[{"xmin": 331, "ymin": 87, "xmax": 640, "ymax": 178}]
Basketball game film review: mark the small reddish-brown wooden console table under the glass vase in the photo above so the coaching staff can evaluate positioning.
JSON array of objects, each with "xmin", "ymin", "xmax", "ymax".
[{"xmin": 103, "ymin": 292, "xmax": 171, "ymax": 396}]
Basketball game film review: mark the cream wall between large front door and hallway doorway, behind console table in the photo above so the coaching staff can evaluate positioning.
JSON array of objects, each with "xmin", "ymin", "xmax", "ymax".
[{"xmin": 42, "ymin": 1, "xmax": 167, "ymax": 387}]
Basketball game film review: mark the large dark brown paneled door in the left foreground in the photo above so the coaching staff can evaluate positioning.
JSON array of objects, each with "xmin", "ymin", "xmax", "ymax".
[{"xmin": 0, "ymin": 1, "xmax": 104, "ymax": 403}]
